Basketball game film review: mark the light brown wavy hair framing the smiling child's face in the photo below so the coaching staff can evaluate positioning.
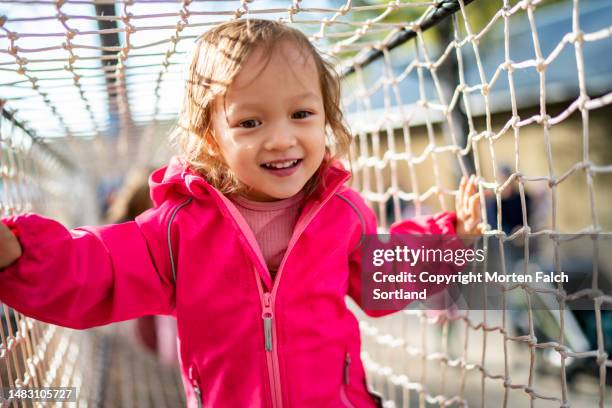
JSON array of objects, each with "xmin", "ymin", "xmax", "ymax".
[{"xmin": 171, "ymin": 19, "xmax": 352, "ymax": 194}]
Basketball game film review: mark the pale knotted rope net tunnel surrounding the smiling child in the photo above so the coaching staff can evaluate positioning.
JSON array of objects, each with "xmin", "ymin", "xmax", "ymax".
[{"xmin": 0, "ymin": 0, "xmax": 612, "ymax": 407}]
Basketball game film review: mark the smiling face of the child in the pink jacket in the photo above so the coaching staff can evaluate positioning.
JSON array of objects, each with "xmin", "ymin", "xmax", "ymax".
[{"xmin": 213, "ymin": 42, "xmax": 325, "ymax": 201}]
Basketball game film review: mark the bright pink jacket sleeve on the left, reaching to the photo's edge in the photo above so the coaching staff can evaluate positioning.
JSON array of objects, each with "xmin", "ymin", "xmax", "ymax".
[{"xmin": 0, "ymin": 210, "xmax": 174, "ymax": 329}]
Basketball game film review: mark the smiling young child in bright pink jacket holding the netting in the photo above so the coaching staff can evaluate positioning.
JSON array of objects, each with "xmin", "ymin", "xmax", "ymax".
[{"xmin": 0, "ymin": 19, "xmax": 480, "ymax": 408}]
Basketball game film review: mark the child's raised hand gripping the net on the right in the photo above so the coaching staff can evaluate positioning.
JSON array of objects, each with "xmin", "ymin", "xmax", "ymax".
[{"xmin": 455, "ymin": 174, "xmax": 485, "ymax": 242}]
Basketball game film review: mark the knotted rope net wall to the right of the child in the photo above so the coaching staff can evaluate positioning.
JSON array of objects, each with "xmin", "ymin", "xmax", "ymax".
[{"xmin": 343, "ymin": 1, "xmax": 612, "ymax": 407}]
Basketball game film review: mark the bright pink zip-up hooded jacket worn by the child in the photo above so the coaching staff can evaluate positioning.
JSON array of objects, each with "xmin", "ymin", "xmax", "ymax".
[{"xmin": 0, "ymin": 159, "xmax": 454, "ymax": 408}]
